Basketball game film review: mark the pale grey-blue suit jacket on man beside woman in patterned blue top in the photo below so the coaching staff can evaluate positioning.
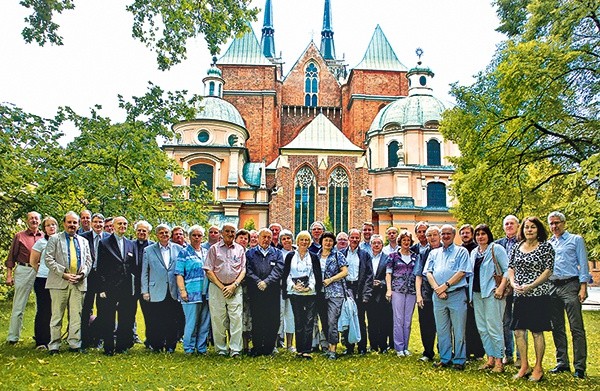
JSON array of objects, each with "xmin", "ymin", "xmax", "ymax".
[{"xmin": 142, "ymin": 242, "xmax": 183, "ymax": 302}]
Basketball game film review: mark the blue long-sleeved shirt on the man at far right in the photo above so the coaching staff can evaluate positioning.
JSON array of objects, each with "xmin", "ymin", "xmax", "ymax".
[{"xmin": 549, "ymin": 231, "xmax": 590, "ymax": 283}]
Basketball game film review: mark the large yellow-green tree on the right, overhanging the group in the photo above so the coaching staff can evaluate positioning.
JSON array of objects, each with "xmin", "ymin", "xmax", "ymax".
[{"xmin": 441, "ymin": 0, "xmax": 600, "ymax": 256}]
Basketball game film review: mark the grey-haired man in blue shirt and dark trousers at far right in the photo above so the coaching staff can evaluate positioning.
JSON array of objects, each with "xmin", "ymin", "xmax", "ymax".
[{"xmin": 548, "ymin": 211, "xmax": 590, "ymax": 379}]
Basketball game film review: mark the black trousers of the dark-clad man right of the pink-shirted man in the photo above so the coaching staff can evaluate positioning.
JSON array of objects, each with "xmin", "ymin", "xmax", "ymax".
[{"xmin": 248, "ymin": 287, "xmax": 281, "ymax": 356}]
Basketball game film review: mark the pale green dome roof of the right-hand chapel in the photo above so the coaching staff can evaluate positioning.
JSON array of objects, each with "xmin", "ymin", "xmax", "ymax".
[{"xmin": 369, "ymin": 95, "xmax": 446, "ymax": 131}]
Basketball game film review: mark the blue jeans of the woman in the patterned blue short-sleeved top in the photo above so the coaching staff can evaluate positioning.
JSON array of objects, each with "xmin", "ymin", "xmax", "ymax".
[{"xmin": 181, "ymin": 302, "xmax": 210, "ymax": 353}]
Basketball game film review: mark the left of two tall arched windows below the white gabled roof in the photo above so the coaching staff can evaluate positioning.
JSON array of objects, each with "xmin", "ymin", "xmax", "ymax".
[{"xmin": 294, "ymin": 167, "xmax": 317, "ymax": 233}]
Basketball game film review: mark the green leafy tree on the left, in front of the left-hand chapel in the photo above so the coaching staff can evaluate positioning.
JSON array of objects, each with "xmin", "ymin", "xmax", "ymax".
[{"xmin": 36, "ymin": 84, "xmax": 210, "ymax": 228}]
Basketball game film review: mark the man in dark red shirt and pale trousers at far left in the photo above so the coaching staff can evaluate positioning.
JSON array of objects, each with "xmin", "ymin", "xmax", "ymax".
[{"xmin": 5, "ymin": 212, "xmax": 44, "ymax": 344}]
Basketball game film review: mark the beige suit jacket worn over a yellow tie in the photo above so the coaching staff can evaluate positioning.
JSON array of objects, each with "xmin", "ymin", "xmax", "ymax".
[{"xmin": 44, "ymin": 232, "xmax": 92, "ymax": 292}]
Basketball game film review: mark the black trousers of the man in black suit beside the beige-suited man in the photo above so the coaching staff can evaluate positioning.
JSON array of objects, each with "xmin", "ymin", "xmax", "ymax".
[{"xmin": 94, "ymin": 288, "xmax": 137, "ymax": 353}]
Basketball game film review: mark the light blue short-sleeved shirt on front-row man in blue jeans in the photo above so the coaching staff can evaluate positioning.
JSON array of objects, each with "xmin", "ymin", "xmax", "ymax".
[{"xmin": 425, "ymin": 243, "xmax": 473, "ymax": 292}]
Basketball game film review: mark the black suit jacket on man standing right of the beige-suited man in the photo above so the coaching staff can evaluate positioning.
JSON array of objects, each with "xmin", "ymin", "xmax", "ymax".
[{"xmin": 97, "ymin": 233, "xmax": 135, "ymax": 295}]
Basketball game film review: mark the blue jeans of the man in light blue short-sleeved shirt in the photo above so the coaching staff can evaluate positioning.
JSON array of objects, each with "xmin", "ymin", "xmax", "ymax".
[{"xmin": 433, "ymin": 289, "xmax": 467, "ymax": 364}]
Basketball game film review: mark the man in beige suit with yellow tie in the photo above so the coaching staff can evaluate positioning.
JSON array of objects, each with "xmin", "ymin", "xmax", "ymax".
[{"xmin": 45, "ymin": 212, "xmax": 92, "ymax": 354}]
